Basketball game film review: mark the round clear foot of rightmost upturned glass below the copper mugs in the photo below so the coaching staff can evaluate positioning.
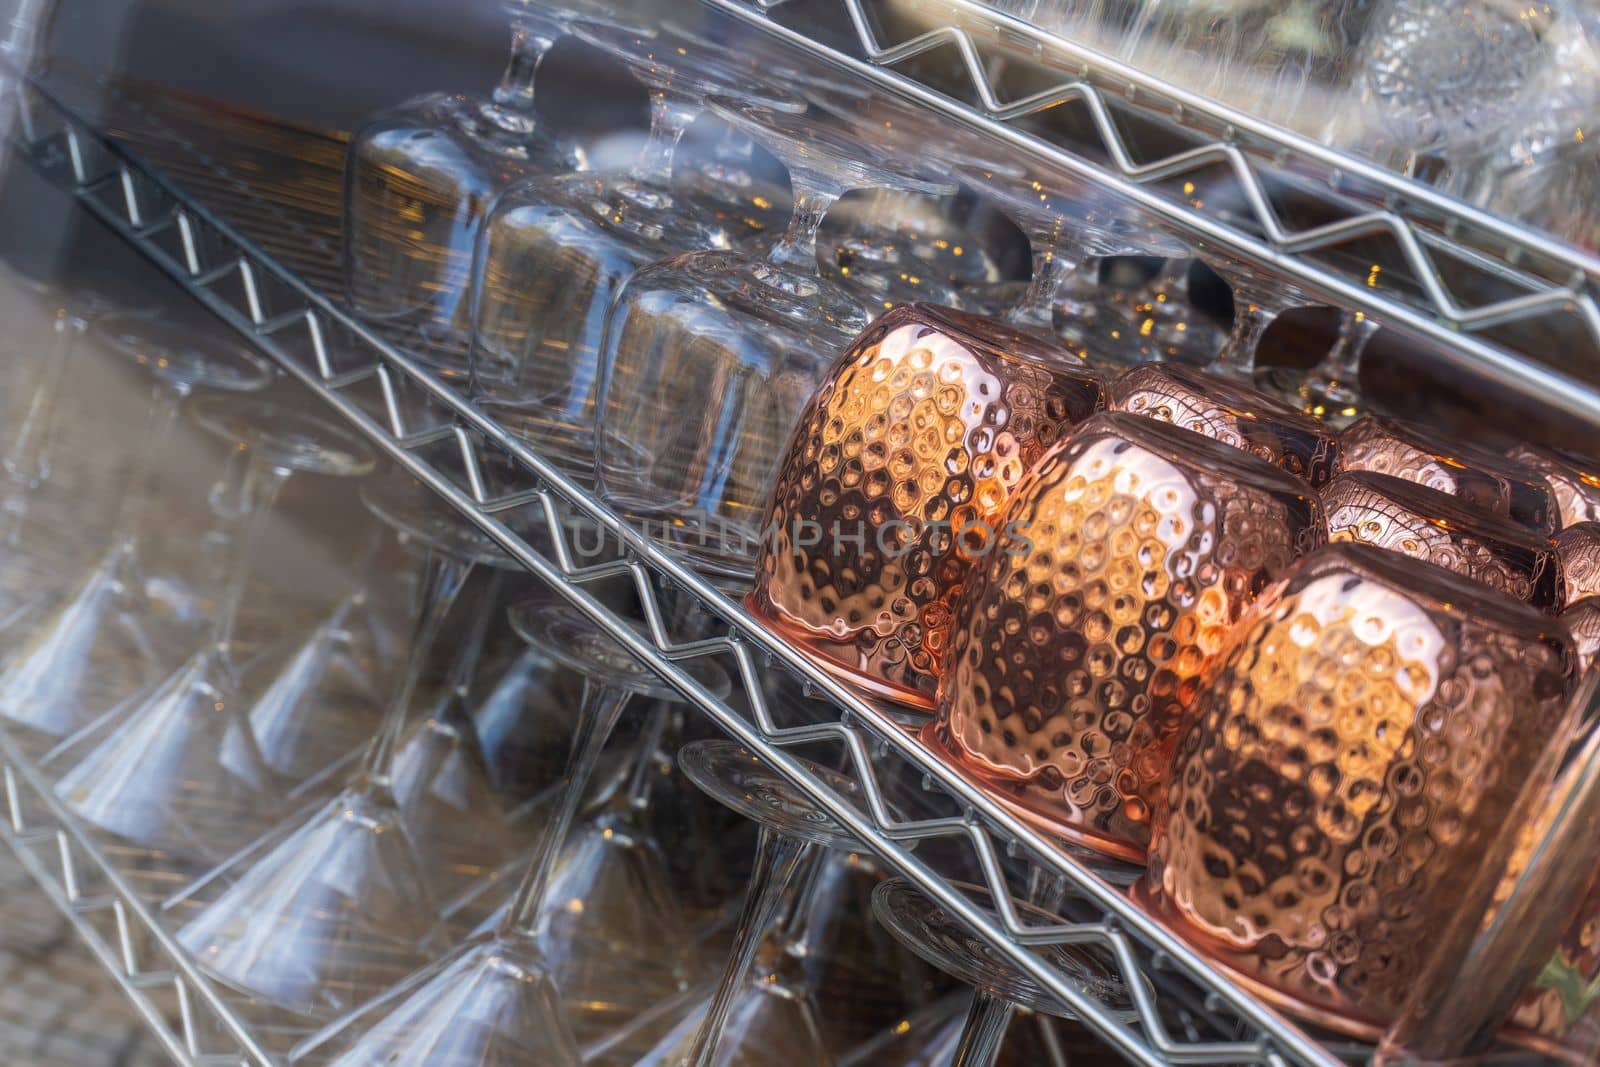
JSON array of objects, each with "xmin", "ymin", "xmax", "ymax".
[{"xmin": 872, "ymin": 878, "xmax": 1154, "ymax": 1022}]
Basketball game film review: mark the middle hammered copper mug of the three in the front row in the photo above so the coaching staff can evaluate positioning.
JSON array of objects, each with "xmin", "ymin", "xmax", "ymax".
[{"xmin": 923, "ymin": 413, "xmax": 1323, "ymax": 861}]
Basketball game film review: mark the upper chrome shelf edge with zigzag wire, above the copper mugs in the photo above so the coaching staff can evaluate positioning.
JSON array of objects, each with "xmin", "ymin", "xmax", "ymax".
[{"xmin": 702, "ymin": 0, "xmax": 1600, "ymax": 422}]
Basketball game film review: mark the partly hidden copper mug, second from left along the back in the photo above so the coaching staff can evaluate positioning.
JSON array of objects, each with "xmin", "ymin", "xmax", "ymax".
[{"xmin": 1334, "ymin": 414, "xmax": 1557, "ymax": 533}]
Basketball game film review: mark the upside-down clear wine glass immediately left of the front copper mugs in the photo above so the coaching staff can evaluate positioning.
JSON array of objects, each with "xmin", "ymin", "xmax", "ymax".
[{"xmin": 597, "ymin": 98, "xmax": 952, "ymax": 582}]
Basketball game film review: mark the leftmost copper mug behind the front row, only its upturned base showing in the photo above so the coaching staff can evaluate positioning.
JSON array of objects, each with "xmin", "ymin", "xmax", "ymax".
[{"xmin": 1107, "ymin": 363, "xmax": 1339, "ymax": 485}]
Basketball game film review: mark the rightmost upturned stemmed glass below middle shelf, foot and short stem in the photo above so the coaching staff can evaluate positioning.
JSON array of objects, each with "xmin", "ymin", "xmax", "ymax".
[{"xmin": 872, "ymin": 878, "xmax": 1138, "ymax": 1067}]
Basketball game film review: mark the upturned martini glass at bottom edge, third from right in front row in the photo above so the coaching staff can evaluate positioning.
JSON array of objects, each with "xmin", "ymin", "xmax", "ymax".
[{"xmin": 290, "ymin": 601, "xmax": 728, "ymax": 1067}]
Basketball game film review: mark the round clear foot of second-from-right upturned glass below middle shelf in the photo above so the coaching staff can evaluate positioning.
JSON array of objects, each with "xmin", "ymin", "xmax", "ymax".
[{"xmin": 678, "ymin": 741, "xmax": 861, "ymax": 853}]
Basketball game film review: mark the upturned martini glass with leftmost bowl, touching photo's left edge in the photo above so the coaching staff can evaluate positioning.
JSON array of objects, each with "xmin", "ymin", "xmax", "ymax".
[{"xmin": 0, "ymin": 314, "xmax": 272, "ymax": 737}]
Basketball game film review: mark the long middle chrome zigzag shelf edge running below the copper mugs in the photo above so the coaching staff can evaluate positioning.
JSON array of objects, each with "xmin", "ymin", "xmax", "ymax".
[{"xmin": 6, "ymin": 75, "xmax": 1341, "ymax": 1065}]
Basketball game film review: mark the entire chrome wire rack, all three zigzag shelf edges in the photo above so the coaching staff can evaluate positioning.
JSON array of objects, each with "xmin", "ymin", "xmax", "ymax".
[{"xmin": 0, "ymin": 0, "xmax": 1600, "ymax": 1065}]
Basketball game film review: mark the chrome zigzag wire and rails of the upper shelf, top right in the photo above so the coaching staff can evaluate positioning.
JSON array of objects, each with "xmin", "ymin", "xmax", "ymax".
[{"xmin": 702, "ymin": 0, "xmax": 1600, "ymax": 422}]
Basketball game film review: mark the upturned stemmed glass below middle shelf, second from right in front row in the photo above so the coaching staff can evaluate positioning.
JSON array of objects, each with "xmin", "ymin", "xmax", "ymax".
[{"xmin": 665, "ymin": 741, "xmax": 861, "ymax": 1067}]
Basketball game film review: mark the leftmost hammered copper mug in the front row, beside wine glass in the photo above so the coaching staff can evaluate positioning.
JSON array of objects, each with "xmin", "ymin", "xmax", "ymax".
[{"xmin": 747, "ymin": 304, "xmax": 1104, "ymax": 709}]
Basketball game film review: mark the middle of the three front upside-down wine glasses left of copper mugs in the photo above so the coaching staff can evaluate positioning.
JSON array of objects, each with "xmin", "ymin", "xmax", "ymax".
[{"xmin": 472, "ymin": 21, "xmax": 803, "ymax": 482}]
